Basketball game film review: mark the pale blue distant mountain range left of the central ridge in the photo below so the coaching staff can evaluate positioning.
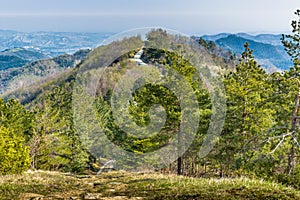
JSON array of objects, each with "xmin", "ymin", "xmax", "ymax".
[{"xmin": 0, "ymin": 30, "xmax": 113, "ymax": 57}]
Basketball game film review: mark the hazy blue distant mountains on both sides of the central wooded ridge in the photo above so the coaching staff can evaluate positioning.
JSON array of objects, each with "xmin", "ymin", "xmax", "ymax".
[{"xmin": 0, "ymin": 30, "xmax": 292, "ymax": 71}]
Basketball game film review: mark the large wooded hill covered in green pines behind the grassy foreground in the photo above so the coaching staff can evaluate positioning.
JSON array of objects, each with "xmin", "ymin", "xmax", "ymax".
[{"xmin": 0, "ymin": 25, "xmax": 300, "ymax": 198}]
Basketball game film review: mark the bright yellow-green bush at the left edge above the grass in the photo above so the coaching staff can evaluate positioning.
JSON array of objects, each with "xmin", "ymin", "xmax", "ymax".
[{"xmin": 0, "ymin": 126, "xmax": 30, "ymax": 175}]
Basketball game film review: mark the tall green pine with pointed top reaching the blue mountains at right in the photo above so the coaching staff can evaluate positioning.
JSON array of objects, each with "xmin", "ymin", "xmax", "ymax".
[{"xmin": 218, "ymin": 43, "xmax": 275, "ymax": 176}]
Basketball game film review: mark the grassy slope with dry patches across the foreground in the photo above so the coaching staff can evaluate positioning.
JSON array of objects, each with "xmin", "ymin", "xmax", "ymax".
[{"xmin": 0, "ymin": 172, "xmax": 300, "ymax": 199}]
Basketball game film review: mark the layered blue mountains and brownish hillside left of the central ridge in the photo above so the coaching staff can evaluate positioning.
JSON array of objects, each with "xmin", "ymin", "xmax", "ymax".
[{"xmin": 0, "ymin": 30, "xmax": 112, "ymax": 94}]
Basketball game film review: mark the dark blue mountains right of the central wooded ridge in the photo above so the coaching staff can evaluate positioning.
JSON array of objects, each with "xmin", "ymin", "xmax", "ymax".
[{"xmin": 201, "ymin": 33, "xmax": 293, "ymax": 72}]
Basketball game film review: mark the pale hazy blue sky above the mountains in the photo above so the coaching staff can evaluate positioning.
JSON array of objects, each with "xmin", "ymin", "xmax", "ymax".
[{"xmin": 0, "ymin": 0, "xmax": 300, "ymax": 35}]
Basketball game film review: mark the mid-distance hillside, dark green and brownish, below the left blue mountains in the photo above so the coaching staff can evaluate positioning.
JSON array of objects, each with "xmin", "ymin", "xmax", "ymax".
[{"xmin": 0, "ymin": 50, "xmax": 90, "ymax": 94}]
